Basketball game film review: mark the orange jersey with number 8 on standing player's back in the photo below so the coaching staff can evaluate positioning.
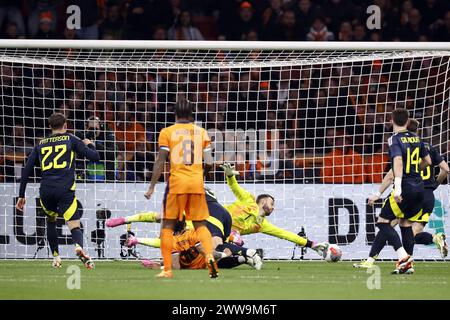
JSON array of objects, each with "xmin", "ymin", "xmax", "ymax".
[{"xmin": 159, "ymin": 123, "xmax": 211, "ymax": 194}]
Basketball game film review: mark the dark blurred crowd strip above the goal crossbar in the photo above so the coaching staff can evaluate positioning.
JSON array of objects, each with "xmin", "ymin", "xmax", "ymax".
[{"xmin": 0, "ymin": 0, "xmax": 450, "ymax": 41}]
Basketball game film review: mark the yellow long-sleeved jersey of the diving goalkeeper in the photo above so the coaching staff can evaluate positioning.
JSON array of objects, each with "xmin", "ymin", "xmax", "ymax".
[{"xmin": 224, "ymin": 176, "xmax": 306, "ymax": 246}]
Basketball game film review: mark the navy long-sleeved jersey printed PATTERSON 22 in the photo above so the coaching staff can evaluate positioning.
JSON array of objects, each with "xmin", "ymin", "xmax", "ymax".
[{"xmin": 19, "ymin": 133, "xmax": 100, "ymax": 198}]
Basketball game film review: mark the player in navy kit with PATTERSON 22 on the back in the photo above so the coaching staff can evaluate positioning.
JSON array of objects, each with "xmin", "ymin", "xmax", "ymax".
[{"xmin": 16, "ymin": 113, "xmax": 100, "ymax": 269}]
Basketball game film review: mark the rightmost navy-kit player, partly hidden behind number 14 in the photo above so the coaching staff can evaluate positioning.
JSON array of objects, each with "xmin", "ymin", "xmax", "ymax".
[{"xmin": 353, "ymin": 119, "xmax": 449, "ymax": 268}]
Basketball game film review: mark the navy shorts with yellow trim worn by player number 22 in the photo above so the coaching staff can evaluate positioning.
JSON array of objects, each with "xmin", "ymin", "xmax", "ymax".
[{"xmin": 39, "ymin": 186, "xmax": 81, "ymax": 221}]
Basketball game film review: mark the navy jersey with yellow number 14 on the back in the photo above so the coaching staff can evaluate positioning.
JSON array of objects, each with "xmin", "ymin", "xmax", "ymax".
[{"xmin": 389, "ymin": 131, "xmax": 428, "ymax": 186}]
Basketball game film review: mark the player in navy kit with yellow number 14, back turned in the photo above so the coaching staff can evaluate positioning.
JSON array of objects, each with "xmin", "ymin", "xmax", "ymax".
[{"xmin": 356, "ymin": 108, "xmax": 432, "ymax": 274}]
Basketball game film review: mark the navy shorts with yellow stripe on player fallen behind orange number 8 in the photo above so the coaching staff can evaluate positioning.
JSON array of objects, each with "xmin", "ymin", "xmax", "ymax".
[{"xmin": 206, "ymin": 201, "xmax": 233, "ymax": 241}]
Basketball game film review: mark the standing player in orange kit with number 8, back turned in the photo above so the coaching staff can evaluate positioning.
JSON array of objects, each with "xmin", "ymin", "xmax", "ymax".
[{"xmin": 145, "ymin": 101, "xmax": 218, "ymax": 278}]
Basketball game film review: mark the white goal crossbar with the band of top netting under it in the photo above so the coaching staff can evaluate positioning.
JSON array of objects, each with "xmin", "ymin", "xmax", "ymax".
[{"xmin": 0, "ymin": 40, "xmax": 450, "ymax": 69}]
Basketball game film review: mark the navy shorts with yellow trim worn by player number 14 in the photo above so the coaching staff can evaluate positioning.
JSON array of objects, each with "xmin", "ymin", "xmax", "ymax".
[{"xmin": 380, "ymin": 188, "xmax": 424, "ymax": 222}]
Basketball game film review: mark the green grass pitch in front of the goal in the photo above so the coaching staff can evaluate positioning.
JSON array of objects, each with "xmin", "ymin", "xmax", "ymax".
[{"xmin": 0, "ymin": 260, "xmax": 450, "ymax": 300}]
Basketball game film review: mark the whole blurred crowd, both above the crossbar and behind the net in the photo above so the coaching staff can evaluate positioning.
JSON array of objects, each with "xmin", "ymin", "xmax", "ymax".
[{"xmin": 0, "ymin": 0, "xmax": 450, "ymax": 183}]
